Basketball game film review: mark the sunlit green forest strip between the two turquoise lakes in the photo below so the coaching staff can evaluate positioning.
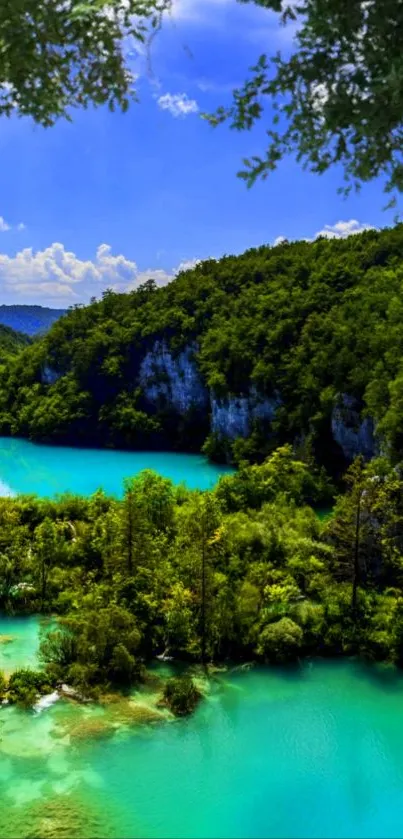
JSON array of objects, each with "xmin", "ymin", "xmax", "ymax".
[{"xmin": 0, "ymin": 446, "xmax": 403, "ymax": 709}]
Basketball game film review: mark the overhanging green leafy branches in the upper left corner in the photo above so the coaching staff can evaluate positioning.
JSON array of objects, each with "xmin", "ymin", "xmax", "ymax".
[{"xmin": 0, "ymin": 0, "xmax": 170, "ymax": 126}]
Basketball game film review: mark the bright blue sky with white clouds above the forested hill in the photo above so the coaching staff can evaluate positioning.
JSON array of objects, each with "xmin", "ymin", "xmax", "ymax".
[{"xmin": 0, "ymin": 0, "xmax": 393, "ymax": 307}]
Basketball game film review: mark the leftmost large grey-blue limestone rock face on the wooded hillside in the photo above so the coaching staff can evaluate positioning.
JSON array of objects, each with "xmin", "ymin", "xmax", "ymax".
[{"xmin": 139, "ymin": 341, "xmax": 209, "ymax": 414}]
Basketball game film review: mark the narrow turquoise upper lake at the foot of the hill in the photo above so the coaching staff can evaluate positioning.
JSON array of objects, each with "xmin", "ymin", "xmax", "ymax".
[{"xmin": 0, "ymin": 437, "xmax": 233, "ymax": 497}]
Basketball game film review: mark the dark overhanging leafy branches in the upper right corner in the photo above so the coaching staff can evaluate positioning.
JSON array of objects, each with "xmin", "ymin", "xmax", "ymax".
[{"xmin": 210, "ymin": 0, "xmax": 403, "ymax": 203}]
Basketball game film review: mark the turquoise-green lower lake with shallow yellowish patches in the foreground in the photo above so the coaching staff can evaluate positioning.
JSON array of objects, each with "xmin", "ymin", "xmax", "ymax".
[{"xmin": 0, "ymin": 619, "xmax": 403, "ymax": 839}]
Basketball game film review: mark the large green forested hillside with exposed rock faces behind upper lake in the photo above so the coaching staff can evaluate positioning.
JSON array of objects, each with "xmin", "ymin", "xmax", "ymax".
[{"xmin": 0, "ymin": 225, "xmax": 403, "ymax": 470}]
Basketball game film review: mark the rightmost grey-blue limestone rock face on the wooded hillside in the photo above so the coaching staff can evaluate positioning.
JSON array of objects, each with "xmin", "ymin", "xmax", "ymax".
[{"xmin": 331, "ymin": 393, "xmax": 378, "ymax": 460}]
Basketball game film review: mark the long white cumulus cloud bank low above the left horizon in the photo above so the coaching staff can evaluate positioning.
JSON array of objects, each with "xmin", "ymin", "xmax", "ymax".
[{"xmin": 0, "ymin": 242, "xmax": 201, "ymax": 307}]
